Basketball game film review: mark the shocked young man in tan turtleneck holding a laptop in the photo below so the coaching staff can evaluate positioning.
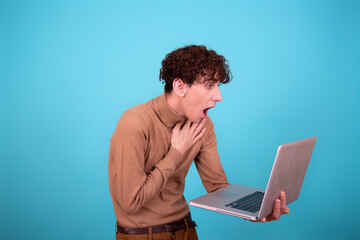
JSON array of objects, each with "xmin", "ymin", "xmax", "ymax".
[{"xmin": 109, "ymin": 45, "xmax": 289, "ymax": 239}]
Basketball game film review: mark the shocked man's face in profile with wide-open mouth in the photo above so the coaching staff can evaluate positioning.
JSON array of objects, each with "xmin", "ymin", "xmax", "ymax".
[{"xmin": 183, "ymin": 77, "xmax": 222, "ymax": 122}]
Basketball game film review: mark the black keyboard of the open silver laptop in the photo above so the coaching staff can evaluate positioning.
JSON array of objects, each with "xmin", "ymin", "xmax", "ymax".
[{"xmin": 225, "ymin": 191, "xmax": 264, "ymax": 213}]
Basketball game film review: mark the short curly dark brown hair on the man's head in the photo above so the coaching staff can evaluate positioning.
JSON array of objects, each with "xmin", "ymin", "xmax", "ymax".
[{"xmin": 159, "ymin": 45, "xmax": 232, "ymax": 93}]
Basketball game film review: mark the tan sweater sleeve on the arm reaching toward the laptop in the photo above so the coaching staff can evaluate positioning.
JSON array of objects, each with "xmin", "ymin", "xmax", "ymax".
[{"xmin": 195, "ymin": 117, "xmax": 229, "ymax": 193}]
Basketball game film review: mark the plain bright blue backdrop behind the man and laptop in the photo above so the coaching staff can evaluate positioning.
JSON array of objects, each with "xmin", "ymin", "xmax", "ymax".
[{"xmin": 0, "ymin": 0, "xmax": 360, "ymax": 240}]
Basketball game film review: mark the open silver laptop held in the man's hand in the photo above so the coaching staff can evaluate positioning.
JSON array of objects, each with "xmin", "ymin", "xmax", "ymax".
[{"xmin": 189, "ymin": 137, "xmax": 316, "ymax": 221}]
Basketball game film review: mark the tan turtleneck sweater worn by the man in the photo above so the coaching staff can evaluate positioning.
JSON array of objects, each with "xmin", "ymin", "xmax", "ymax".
[{"xmin": 108, "ymin": 93, "xmax": 229, "ymax": 227}]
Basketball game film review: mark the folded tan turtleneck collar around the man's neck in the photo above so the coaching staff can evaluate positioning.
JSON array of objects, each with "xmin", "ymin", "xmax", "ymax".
[{"xmin": 151, "ymin": 92, "xmax": 186, "ymax": 128}]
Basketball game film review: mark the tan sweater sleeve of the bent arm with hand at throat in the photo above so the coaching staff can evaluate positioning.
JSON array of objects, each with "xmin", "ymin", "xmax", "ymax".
[{"xmin": 109, "ymin": 111, "xmax": 182, "ymax": 214}]
